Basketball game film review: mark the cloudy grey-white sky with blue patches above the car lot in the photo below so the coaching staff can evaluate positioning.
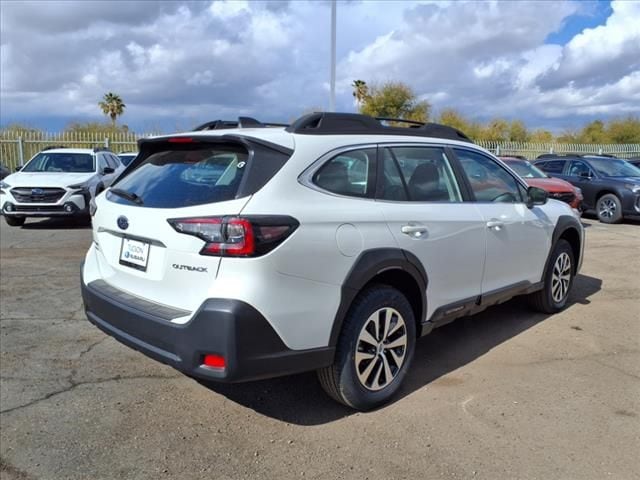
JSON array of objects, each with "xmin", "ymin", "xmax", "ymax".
[{"xmin": 0, "ymin": 0, "xmax": 640, "ymax": 131}]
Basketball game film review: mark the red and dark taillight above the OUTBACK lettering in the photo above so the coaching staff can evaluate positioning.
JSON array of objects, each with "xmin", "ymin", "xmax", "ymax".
[{"xmin": 168, "ymin": 215, "xmax": 299, "ymax": 257}]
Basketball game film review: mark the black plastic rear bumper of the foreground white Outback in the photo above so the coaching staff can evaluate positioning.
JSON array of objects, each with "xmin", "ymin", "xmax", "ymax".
[{"xmin": 82, "ymin": 270, "xmax": 334, "ymax": 382}]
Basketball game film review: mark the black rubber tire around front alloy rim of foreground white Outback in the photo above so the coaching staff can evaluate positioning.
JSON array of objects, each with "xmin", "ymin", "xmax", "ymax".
[{"xmin": 529, "ymin": 239, "xmax": 576, "ymax": 313}]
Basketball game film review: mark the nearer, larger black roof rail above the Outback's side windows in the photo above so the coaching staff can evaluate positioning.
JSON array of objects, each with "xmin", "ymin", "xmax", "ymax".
[{"xmin": 285, "ymin": 112, "xmax": 473, "ymax": 143}]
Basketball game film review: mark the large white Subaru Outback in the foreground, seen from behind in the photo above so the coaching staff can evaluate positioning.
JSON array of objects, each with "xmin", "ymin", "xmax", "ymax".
[{"xmin": 82, "ymin": 113, "xmax": 584, "ymax": 410}]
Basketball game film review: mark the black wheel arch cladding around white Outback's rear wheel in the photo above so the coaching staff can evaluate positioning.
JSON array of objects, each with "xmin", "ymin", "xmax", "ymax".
[{"xmin": 329, "ymin": 248, "xmax": 428, "ymax": 346}]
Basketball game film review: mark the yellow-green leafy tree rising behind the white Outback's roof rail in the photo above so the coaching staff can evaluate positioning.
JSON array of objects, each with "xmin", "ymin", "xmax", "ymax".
[{"xmin": 354, "ymin": 82, "xmax": 431, "ymax": 122}]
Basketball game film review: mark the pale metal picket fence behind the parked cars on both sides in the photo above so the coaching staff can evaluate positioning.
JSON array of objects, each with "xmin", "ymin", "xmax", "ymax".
[{"xmin": 0, "ymin": 130, "xmax": 640, "ymax": 170}]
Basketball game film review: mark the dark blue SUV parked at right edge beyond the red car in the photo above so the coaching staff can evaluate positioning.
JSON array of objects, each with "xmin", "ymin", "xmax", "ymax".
[{"xmin": 534, "ymin": 154, "xmax": 640, "ymax": 223}]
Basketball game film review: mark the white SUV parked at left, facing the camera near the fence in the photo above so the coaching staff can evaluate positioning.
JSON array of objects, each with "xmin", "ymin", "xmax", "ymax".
[{"xmin": 0, "ymin": 147, "xmax": 124, "ymax": 227}]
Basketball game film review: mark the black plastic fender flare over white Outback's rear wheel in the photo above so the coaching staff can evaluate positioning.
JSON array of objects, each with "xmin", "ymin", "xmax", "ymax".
[{"xmin": 329, "ymin": 248, "xmax": 428, "ymax": 347}]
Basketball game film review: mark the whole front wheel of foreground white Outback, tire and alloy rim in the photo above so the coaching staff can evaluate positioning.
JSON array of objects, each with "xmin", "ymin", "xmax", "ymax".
[{"xmin": 529, "ymin": 240, "xmax": 575, "ymax": 313}]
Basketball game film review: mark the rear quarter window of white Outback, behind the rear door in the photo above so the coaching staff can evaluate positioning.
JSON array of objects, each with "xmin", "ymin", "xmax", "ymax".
[{"xmin": 312, "ymin": 148, "xmax": 376, "ymax": 197}]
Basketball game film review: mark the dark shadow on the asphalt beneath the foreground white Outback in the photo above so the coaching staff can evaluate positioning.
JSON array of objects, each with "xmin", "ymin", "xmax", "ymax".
[{"xmin": 203, "ymin": 274, "xmax": 602, "ymax": 425}]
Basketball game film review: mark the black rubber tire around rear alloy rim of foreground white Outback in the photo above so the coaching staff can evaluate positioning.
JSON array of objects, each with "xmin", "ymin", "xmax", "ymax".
[{"xmin": 318, "ymin": 285, "xmax": 416, "ymax": 411}]
